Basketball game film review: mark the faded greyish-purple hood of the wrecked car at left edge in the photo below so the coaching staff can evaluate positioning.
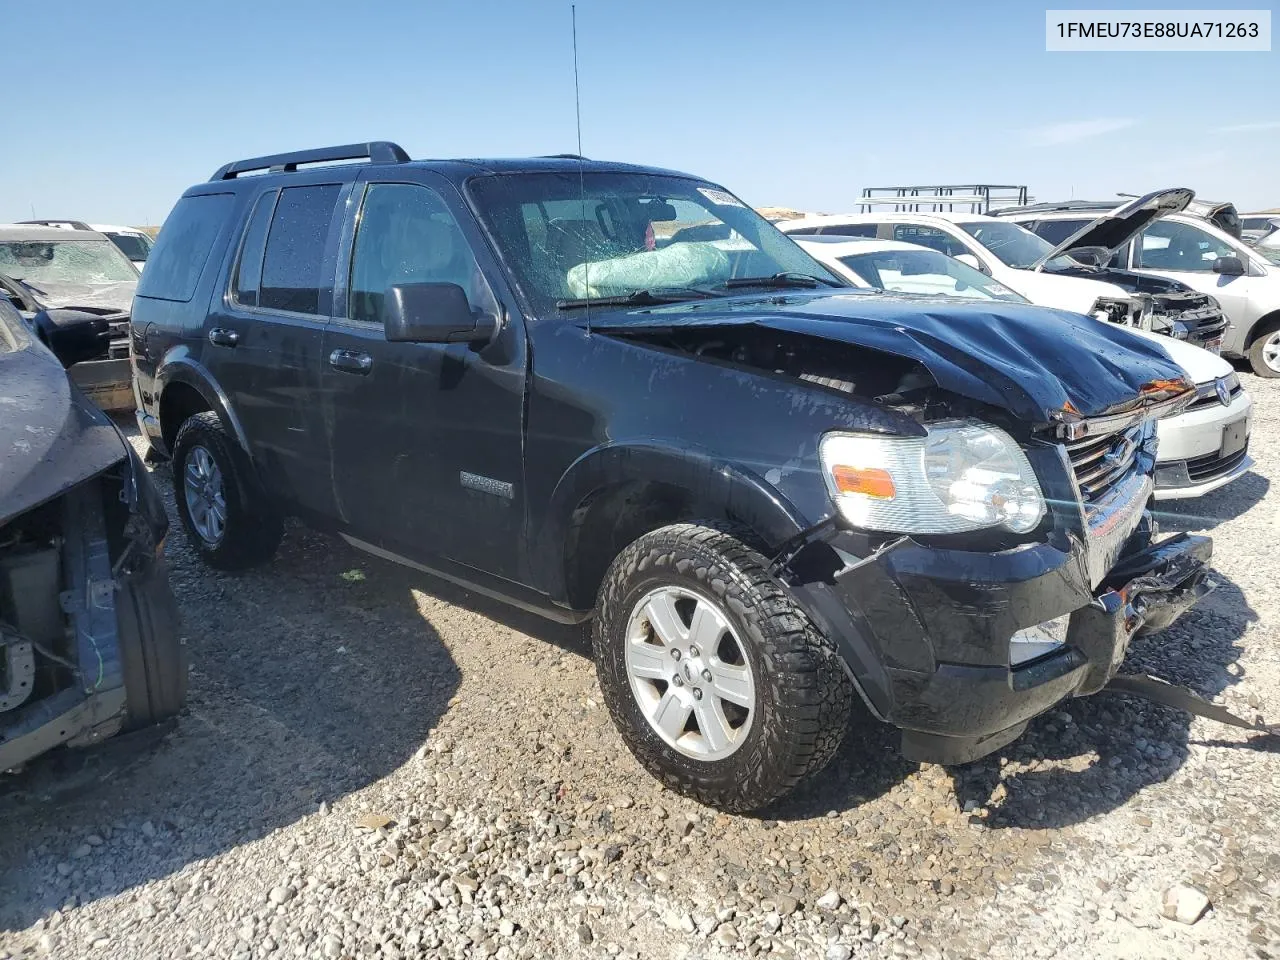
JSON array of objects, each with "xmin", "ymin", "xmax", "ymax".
[{"xmin": 0, "ymin": 307, "xmax": 127, "ymax": 524}]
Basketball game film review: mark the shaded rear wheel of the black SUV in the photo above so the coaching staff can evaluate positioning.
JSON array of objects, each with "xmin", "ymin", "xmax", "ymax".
[{"xmin": 173, "ymin": 411, "xmax": 284, "ymax": 570}]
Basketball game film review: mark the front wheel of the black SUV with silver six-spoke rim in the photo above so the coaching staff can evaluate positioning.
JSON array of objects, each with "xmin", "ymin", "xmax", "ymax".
[{"xmin": 593, "ymin": 524, "xmax": 854, "ymax": 812}]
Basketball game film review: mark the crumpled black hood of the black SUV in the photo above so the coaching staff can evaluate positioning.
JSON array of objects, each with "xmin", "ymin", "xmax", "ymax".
[{"xmin": 591, "ymin": 291, "xmax": 1190, "ymax": 424}]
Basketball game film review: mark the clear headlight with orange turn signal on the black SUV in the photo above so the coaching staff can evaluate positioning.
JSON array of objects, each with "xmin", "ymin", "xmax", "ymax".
[{"xmin": 820, "ymin": 420, "xmax": 1044, "ymax": 534}]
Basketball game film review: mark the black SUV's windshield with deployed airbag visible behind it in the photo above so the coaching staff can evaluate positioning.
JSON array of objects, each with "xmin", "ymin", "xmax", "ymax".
[{"xmin": 471, "ymin": 173, "xmax": 844, "ymax": 308}]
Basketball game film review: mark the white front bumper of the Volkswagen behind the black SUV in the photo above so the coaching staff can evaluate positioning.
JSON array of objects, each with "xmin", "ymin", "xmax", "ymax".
[{"xmin": 1156, "ymin": 390, "xmax": 1253, "ymax": 500}]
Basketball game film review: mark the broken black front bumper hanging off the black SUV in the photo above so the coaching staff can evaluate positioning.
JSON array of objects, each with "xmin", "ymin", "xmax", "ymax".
[{"xmin": 783, "ymin": 526, "xmax": 1212, "ymax": 763}]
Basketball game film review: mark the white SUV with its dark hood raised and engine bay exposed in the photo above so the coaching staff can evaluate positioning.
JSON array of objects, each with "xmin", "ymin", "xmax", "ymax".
[{"xmin": 774, "ymin": 191, "xmax": 1226, "ymax": 349}]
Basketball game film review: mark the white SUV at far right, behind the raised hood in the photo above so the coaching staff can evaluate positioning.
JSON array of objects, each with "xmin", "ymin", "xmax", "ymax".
[{"xmin": 1001, "ymin": 195, "xmax": 1280, "ymax": 378}]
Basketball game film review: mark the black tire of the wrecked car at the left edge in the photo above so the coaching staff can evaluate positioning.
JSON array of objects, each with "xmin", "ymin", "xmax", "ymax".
[{"xmin": 115, "ymin": 561, "xmax": 187, "ymax": 730}]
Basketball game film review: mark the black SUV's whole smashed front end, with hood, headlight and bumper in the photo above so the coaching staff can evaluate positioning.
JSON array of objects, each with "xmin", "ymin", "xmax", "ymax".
[{"xmin": 593, "ymin": 293, "xmax": 1212, "ymax": 763}]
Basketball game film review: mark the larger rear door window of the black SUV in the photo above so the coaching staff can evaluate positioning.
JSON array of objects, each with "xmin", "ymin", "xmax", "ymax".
[{"xmin": 259, "ymin": 183, "xmax": 342, "ymax": 315}]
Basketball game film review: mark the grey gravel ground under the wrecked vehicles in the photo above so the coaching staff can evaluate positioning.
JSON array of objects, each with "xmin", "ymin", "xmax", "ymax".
[{"xmin": 0, "ymin": 376, "xmax": 1280, "ymax": 960}]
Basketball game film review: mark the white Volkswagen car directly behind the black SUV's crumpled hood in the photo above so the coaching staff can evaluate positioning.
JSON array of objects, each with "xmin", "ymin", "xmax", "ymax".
[{"xmin": 795, "ymin": 236, "xmax": 1253, "ymax": 500}]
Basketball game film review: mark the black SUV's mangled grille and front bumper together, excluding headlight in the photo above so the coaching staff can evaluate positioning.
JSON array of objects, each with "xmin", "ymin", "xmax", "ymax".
[{"xmin": 776, "ymin": 381, "xmax": 1213, "ymax": 764}]
